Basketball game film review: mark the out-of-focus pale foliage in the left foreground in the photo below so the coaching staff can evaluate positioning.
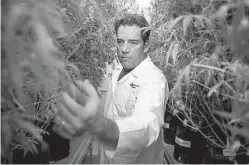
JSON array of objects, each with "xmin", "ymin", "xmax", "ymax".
[{"xmin": 1, "ymin": 0, "xmax": 71, "ymax": 158}]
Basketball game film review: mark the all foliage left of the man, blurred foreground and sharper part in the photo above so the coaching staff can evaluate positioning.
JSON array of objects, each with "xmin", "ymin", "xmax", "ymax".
[{"xmin": 1, "ymin": 0, "xmax": 120, "ymax": 162}]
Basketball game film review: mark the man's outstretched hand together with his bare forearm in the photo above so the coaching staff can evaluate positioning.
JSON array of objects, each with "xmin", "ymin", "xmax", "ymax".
[{"xmin": 53, "ymin": 80, "xmax": 119, "ymax": 150}]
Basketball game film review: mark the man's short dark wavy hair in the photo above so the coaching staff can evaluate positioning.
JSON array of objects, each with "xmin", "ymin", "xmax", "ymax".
[{"xmin": 114, "ymin": 14, "xmax": 150, "ymax": 42}]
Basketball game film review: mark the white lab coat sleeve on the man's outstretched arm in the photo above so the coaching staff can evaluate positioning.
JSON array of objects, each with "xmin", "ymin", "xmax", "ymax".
[{"xmin": 107, "ymin": 76, "xmax": 168, "ymax": 164}]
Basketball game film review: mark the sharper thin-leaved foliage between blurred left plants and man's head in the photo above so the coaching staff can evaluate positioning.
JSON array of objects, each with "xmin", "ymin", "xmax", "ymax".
[{"xmin": 58, "ymin": 0, "xmax": 115, "ymax": 88}]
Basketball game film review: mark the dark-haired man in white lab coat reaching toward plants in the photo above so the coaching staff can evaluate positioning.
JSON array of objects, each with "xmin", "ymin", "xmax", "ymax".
[{"xmin": 53, "ymin": 14, "xmax": 168, "ymax": 164}]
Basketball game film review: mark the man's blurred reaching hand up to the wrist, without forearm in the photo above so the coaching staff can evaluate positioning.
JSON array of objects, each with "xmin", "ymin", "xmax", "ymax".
[{"xmin": 53, "ymin": 80, "xmax": 100, "ymax": 139}]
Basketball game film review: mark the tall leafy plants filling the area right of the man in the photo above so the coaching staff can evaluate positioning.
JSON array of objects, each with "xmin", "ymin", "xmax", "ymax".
[{"xmin": 150, "ymin": 0, "xmax": 249, "ymax": 161}]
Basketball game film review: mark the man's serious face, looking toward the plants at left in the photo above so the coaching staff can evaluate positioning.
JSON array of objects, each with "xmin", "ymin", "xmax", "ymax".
[{"xmin": 117, "ymin": 25, "xmax": 146, "ymax": 70}]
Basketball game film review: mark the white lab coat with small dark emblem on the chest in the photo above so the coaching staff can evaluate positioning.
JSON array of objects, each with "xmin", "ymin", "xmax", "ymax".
[{"xmin": 100, "ymin": 57, "xmax": 168, "ymax": 164}]
